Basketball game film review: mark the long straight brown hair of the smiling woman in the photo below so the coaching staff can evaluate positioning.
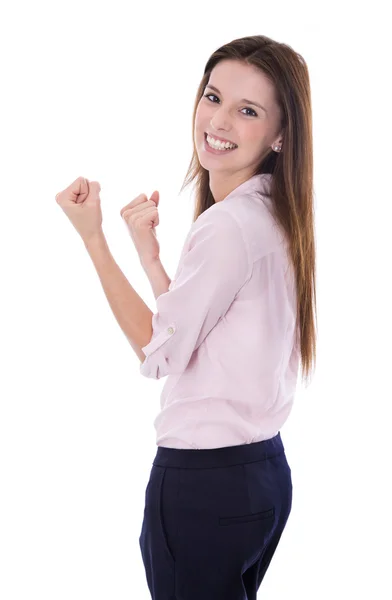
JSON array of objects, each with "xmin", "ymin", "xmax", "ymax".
[{"xmin": 181, "ymin": 35, "xmax": 317, "ymax": 380}]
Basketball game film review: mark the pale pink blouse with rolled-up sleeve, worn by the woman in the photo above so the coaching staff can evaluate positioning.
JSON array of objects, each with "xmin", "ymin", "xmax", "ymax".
[{"xmin": 140, "ymin": 174, "xmax": 300, "ymax": 449}]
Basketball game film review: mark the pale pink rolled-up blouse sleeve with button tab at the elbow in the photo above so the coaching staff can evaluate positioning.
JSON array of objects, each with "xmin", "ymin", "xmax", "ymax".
[{"xmin": 140, "ymin": 207, "xmax": 250, "ymax": 379}]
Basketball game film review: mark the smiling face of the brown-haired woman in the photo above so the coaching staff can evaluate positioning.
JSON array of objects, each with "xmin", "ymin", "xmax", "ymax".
[{"xmin": 194, "ymin": 60, "xmax": 281, "ymax": 180}]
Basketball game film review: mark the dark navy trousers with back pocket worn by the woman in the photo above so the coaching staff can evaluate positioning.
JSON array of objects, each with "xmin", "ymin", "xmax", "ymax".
[{"xmin": 139, "ymin": 432, "xmax": 292, "ymax": 600}]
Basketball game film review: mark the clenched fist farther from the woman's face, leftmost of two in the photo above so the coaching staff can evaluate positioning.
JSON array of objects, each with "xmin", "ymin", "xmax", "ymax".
[{"xmin": 56, "ymin": 177, "xmax": 102, "ymax": 243}]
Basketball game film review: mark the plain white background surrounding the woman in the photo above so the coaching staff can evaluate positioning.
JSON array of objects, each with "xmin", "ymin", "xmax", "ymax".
[{"xmin": 0, "ymin": 0, "xmax": 392, "ymax": 600}]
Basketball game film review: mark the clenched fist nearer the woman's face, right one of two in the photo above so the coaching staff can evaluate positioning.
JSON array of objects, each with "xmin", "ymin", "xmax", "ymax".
[{"xmin": 120, "ymin": 191, "xmax": 159, "ymax": 267}]
